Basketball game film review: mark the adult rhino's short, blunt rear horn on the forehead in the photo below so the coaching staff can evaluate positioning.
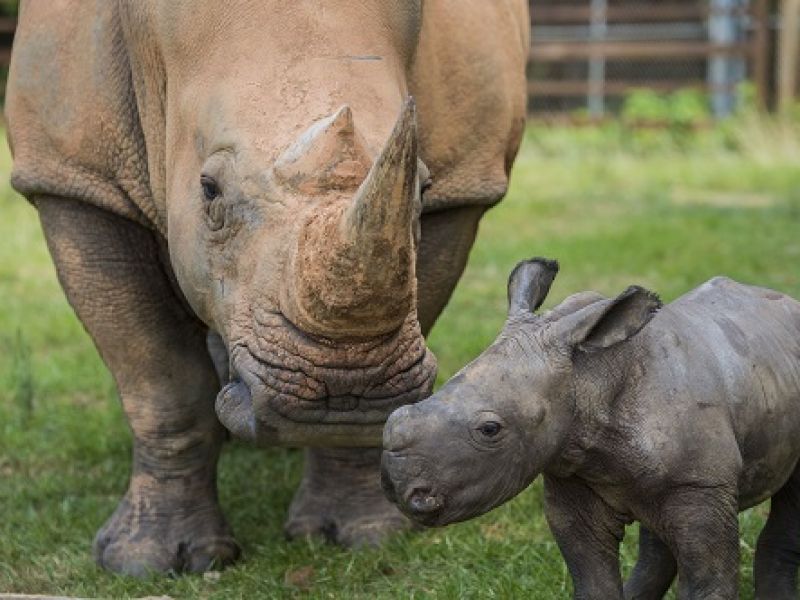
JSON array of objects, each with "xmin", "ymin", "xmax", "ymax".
[{"xmin": 274, "ymin": 104, "xmax": 370, "ymax": 195}]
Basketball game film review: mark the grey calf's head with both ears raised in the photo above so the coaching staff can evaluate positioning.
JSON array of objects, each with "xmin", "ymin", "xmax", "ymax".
[{"xmin": 382, "ymin": 259, "xmax": 660, "ymax": 526}]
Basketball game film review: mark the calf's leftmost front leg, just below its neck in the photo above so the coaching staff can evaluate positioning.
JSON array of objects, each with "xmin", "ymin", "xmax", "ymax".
[{"xmin": 544, "ymin": 476, "xmax": 625, "ymax": 600}]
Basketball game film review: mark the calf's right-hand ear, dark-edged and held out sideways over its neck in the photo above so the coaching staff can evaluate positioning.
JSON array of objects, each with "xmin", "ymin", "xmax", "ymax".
[{"xmin": 555, "ymin": 286, "xmax": 662, "ymax": 352}]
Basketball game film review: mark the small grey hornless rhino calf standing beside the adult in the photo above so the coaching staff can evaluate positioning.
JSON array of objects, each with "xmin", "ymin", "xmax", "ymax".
[{"xmin": 383, "ymin": 259, "xmax": 800, "ymax": 600}]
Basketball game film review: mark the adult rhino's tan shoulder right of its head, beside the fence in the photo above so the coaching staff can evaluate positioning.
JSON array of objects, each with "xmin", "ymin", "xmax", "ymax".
[{"xmin": 409, "ymin": 0, "xmax": 530, "ymax": 211}]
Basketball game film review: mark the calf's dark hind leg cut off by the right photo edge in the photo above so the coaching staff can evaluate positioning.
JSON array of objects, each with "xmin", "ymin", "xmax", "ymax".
[{"xmin": 755, "ymin": 468, "xmax": 800, "ymax": 600}]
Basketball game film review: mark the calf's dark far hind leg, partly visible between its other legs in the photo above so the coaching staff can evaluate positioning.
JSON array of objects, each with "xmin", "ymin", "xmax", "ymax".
[{"xmin": 624, "ymin": 526, "xmax": 678, "ymax": 600}]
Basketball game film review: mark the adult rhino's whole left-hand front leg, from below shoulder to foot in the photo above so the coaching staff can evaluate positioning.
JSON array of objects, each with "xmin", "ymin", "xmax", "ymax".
[{"xmin": 35, "ymin": 198, "xmax": 239, "ymax": 576}]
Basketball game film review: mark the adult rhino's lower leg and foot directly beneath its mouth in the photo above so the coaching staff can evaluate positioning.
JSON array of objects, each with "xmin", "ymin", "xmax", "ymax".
[{"xmin": 284, "ymin": 448, "xmax": 412, "ymax": 547}]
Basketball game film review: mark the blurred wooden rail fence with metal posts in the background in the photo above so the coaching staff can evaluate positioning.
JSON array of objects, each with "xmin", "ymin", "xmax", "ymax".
[{"xmin": 529, "ymin": 0, "xmax": 776, "ymax": 116}]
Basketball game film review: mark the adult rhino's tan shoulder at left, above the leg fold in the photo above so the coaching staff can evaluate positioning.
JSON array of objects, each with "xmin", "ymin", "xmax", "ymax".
[{"xmin": 6, "ymin": 0, "xmax": 157, "ymax": 227}]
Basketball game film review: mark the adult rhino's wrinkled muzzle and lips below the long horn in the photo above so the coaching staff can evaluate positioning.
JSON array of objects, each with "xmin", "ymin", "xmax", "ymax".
[{"xmin": 217, "ymin": 312, "xmax": 436, "ymax": 446}]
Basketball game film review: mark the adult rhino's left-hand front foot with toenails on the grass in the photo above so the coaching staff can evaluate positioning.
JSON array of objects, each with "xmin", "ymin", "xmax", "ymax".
[{"xmin": 94, "ymin": 491, "xmax": 240, "ymax": 577}]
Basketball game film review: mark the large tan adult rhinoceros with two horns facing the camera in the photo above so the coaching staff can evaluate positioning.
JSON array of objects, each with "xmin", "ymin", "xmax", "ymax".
[{"xmin": 6, "ymin": 0, "xmax": 528, "ymax": 574}]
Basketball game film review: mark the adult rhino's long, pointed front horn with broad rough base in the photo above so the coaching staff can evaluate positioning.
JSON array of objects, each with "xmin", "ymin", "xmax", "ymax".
[{"xmin": 285, "ymin": 99, "xmax": 420, "ymax": 339}]
